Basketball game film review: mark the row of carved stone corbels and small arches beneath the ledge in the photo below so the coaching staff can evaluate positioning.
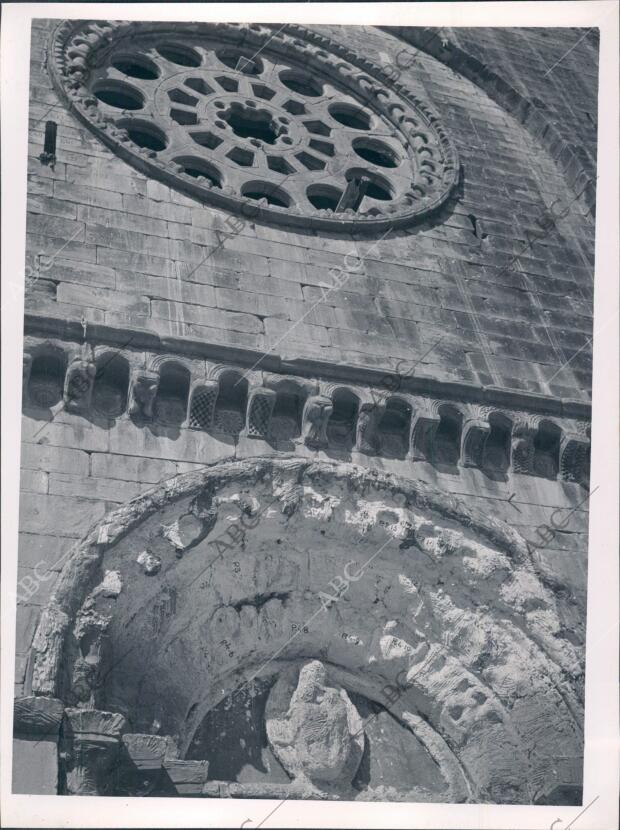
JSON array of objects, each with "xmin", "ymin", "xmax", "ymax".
[{"xmin": 23, "ymin": 337, "xmax": 590, "ymax": 486}]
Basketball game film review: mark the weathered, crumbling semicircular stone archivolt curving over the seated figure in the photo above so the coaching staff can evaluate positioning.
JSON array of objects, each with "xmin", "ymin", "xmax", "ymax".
[{"xmin": 27, "ymin": 458, "xmax": 582, "ymax": 802}]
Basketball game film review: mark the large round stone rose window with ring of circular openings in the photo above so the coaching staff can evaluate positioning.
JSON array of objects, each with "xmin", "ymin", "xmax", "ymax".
[{"xmin": 52, "ymin": 22, "xmax": 458, "ymax": 230}]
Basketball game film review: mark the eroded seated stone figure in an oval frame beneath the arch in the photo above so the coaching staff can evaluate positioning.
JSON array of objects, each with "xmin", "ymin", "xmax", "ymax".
[{"xmin": 266, "ymin": 660, "xmax": 364, "ymax": 788}]
